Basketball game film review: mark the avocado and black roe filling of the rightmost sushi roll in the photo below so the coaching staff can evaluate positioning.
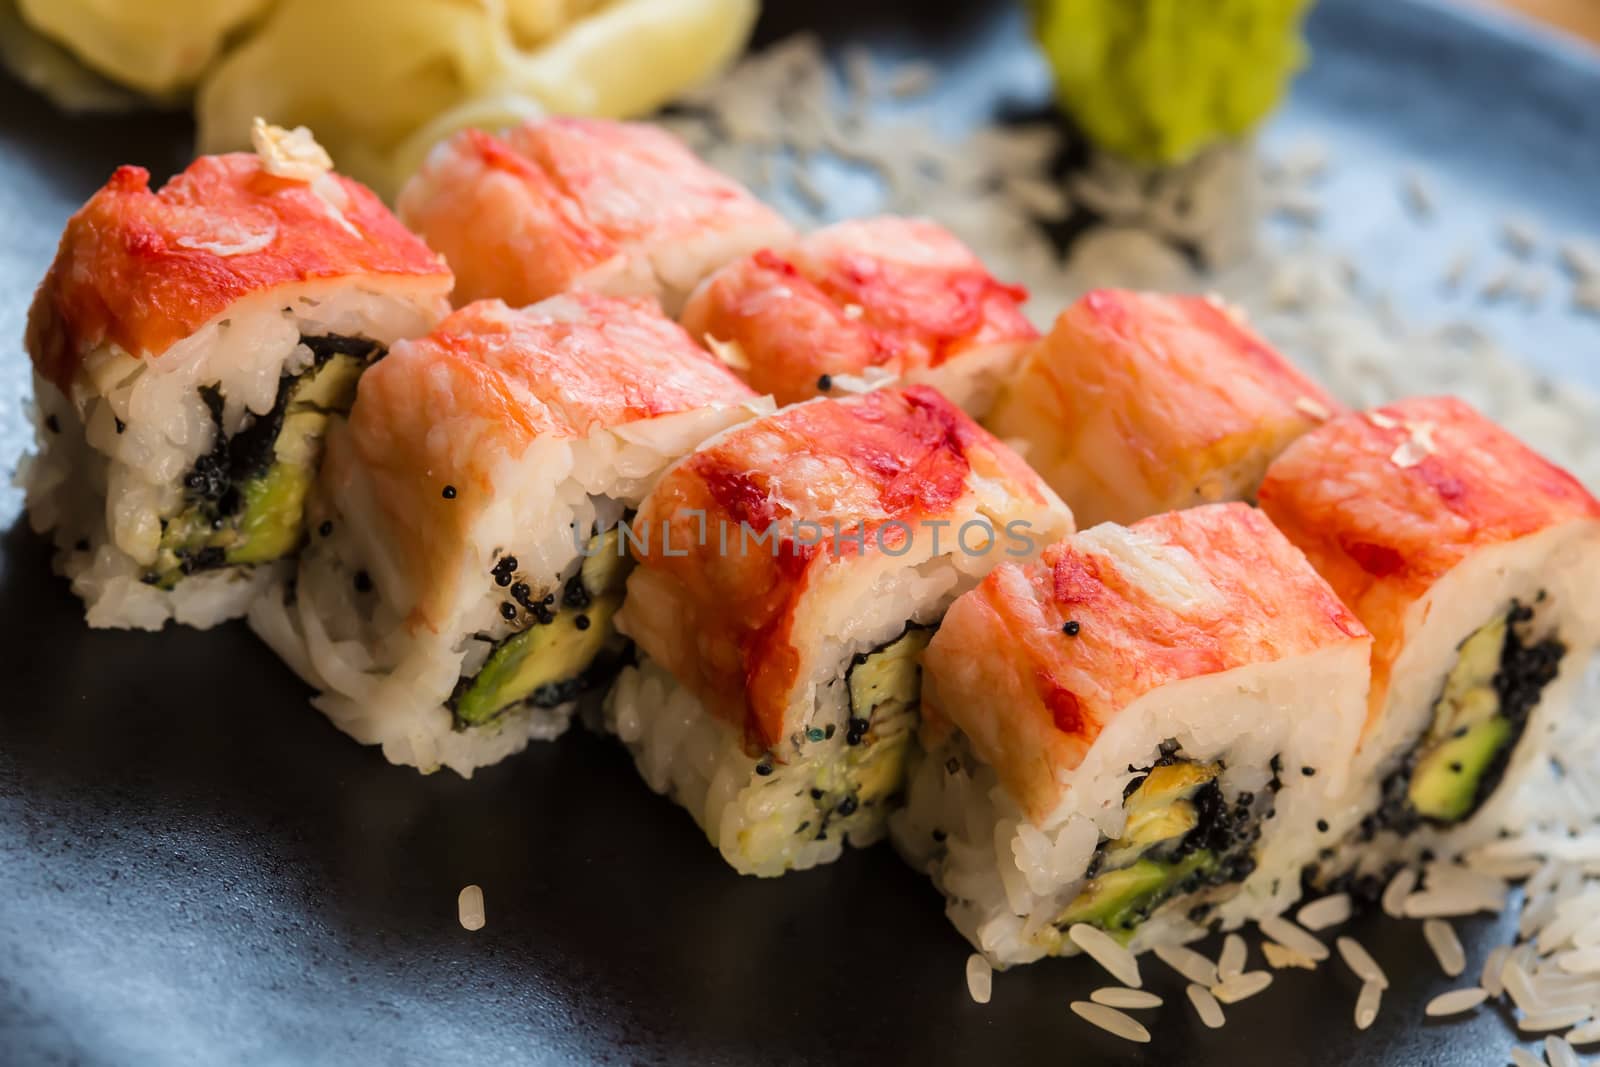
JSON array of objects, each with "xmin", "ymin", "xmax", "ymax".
[{"xmin": 1363, "ymin": 601, "xmax": 1566, "ymax": 837}]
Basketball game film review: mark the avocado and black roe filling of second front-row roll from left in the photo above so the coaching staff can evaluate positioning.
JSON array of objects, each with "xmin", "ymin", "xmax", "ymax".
[{"xmin": 450, "ymin": 526, "xmax": 632, "ymax": 729}]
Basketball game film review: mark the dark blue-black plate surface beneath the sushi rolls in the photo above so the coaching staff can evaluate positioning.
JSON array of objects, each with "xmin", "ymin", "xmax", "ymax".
[{"xmin": 0, "ymin": 0, "xmax": 1600, "ymax": 1064}]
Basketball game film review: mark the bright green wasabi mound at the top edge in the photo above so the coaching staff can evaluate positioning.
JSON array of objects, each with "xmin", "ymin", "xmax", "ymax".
[{"xmin": 1029, "ymin": 0, "xmax": 1310, "ymax": 165}]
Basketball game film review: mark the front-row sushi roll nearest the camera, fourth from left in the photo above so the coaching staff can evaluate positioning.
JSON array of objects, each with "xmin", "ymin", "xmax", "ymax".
[{"xmin": 893, "ymin": 504, "xmax": 1371, "ymax": 965}]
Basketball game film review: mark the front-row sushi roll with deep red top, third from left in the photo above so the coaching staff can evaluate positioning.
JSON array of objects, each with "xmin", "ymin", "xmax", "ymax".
[{"xmin": 606, "ymin": 386, "xmax": 1072, "ymax": 875}]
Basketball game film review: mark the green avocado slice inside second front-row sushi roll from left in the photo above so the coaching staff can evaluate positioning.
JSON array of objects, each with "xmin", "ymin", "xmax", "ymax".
[{"xmin": 451, "ymin": 526, "xmax": 630, "ymax": 729}]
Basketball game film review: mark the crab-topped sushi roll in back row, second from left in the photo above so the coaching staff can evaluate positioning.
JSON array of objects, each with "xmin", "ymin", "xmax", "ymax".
[{"xmin": 680, "ymin": 218, "xmax": 1038, "ymax": 418}]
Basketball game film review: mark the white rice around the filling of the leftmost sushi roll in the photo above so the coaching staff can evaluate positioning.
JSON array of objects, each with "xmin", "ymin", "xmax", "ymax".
[{"xmin": 18, "ymin": 287, "xmax": 445, "ymax": 630}]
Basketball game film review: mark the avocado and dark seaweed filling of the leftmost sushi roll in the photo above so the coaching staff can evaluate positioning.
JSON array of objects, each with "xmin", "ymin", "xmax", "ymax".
[{"xmin": 144, "ymin": 338, "xmax": 384, "ymax": 589}]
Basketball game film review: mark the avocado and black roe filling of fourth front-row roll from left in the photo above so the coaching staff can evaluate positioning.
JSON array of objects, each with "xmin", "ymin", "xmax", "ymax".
[{"xmin": 1053, "ymin": 741, "xmax": 1272, "ymax": 942}]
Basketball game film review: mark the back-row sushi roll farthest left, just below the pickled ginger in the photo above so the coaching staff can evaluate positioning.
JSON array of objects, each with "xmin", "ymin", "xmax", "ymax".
[{"xmin": 398, "ymin": 118, "xmax": 792, "ymax": 314}]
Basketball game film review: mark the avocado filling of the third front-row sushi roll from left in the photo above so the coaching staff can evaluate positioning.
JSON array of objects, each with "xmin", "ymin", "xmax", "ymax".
[{"xmin": 793, "ymin": 622, "xmax": 933, "ymax": 840}]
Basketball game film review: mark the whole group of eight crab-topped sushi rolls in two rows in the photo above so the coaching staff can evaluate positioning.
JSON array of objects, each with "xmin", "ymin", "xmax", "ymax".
[{"xmin": 27, "ymin": 112, "xmax": 1600, "ymax": 965}]
